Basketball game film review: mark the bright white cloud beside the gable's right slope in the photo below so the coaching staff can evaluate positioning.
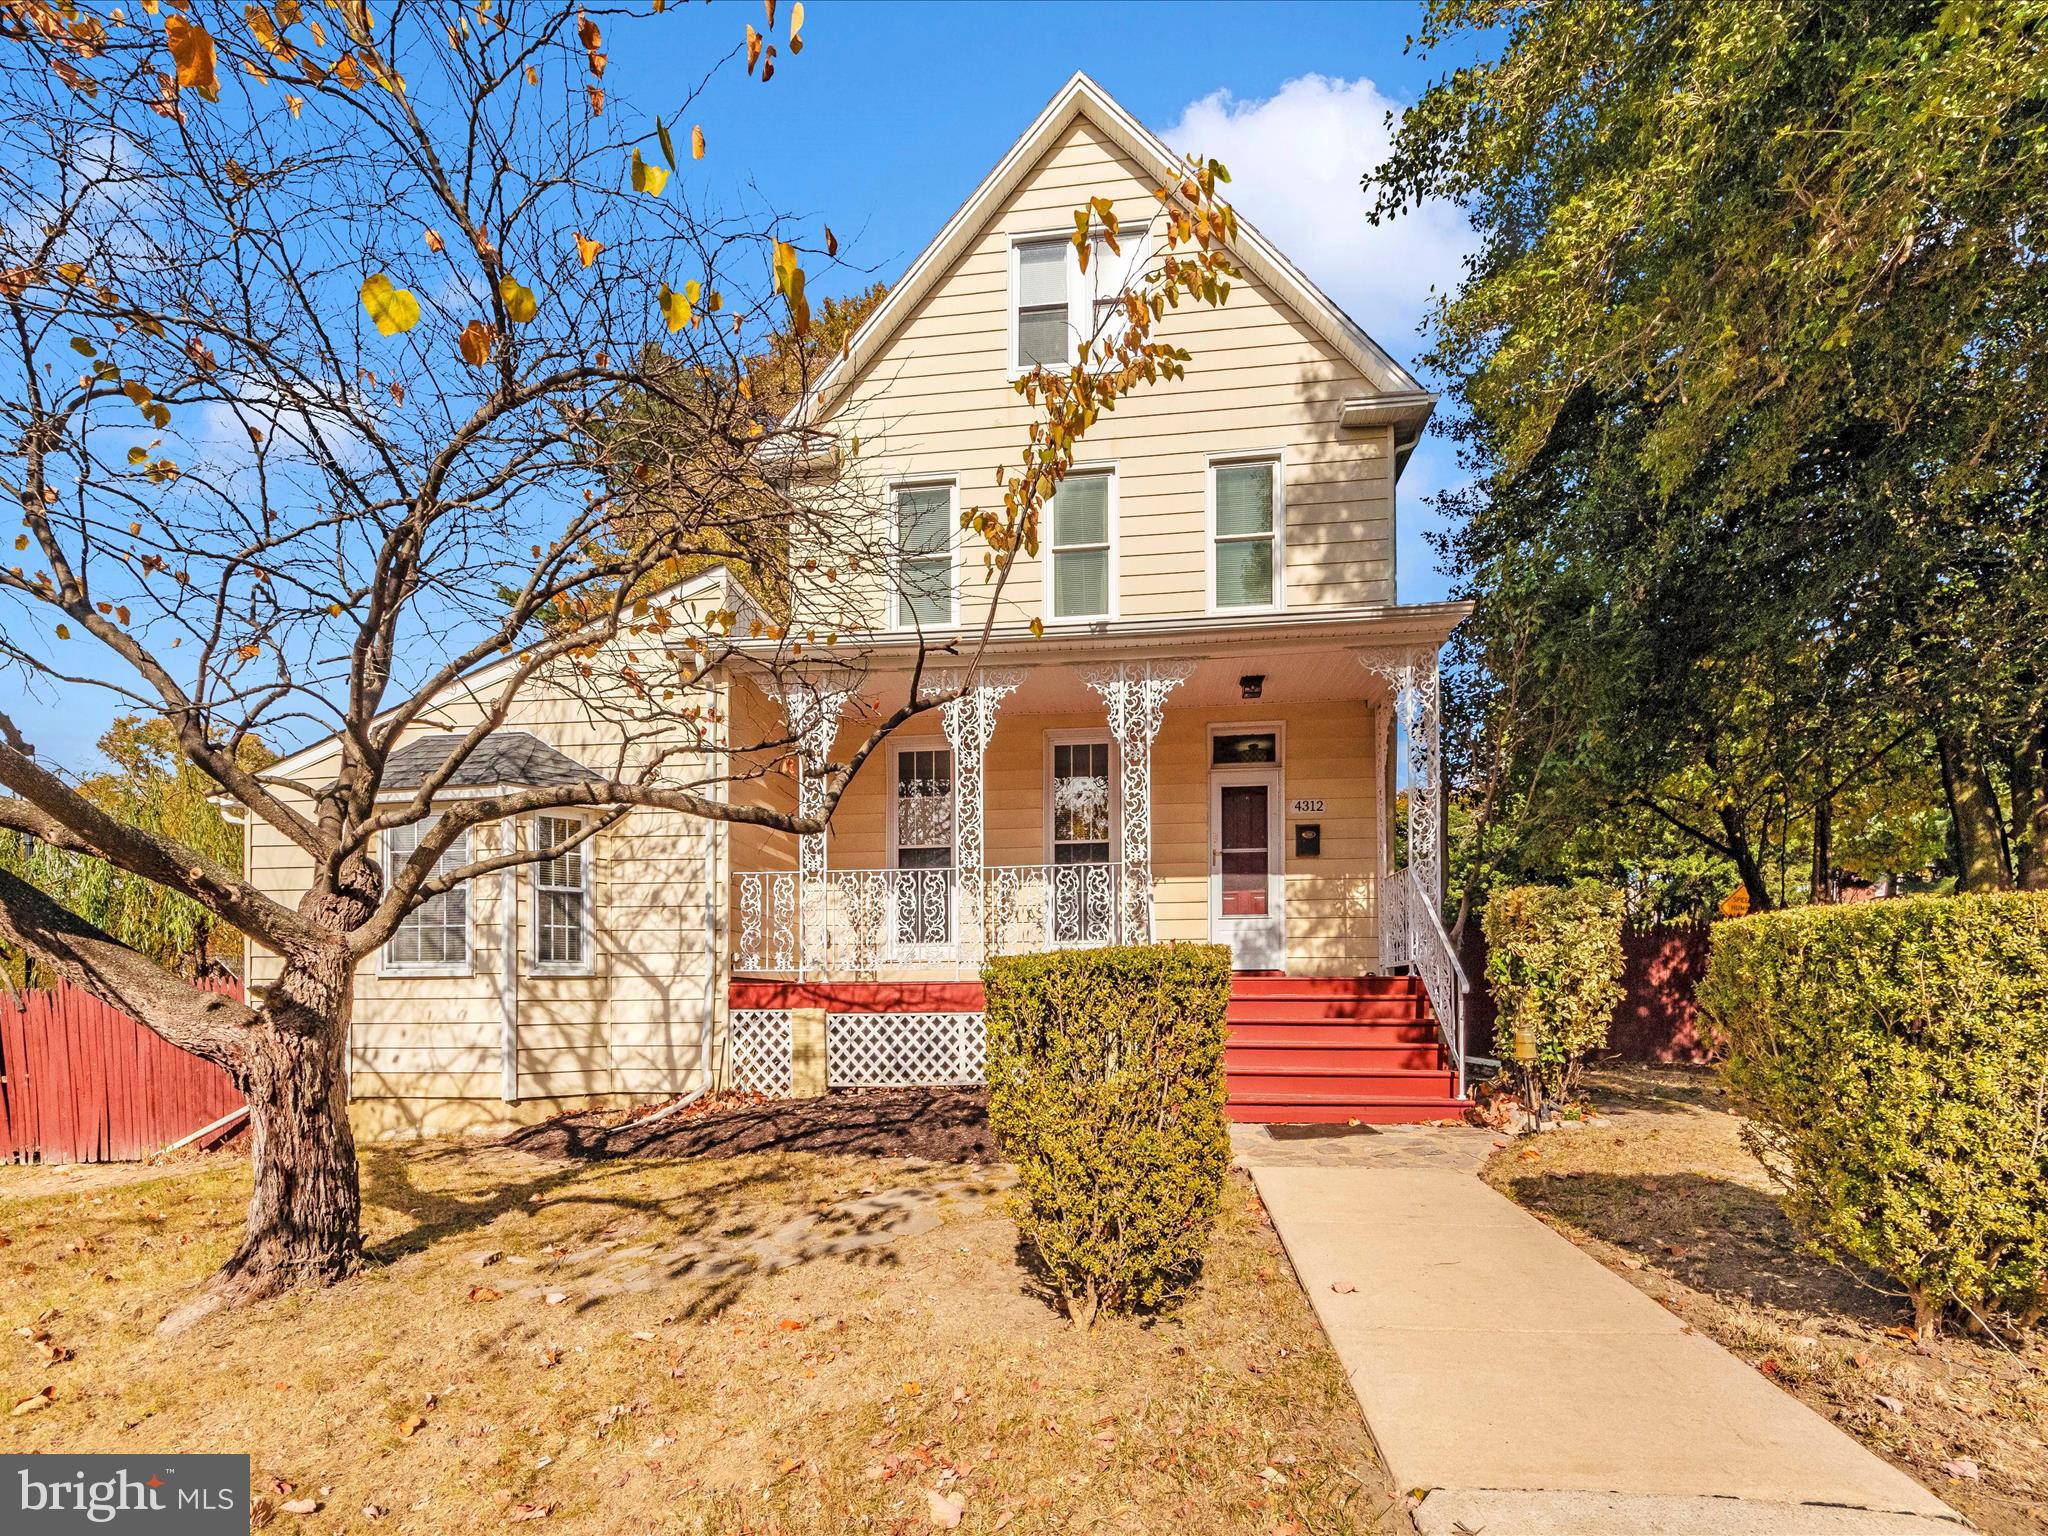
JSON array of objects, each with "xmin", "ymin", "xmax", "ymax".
[{"xmin": 1161, "ymin": 74, "xmax": 1475, "ymax": 367}]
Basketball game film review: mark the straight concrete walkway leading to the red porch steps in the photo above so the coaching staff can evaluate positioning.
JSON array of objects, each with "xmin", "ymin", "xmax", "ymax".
[{"xmin": 1235, "ymin": 1126, "xmax": 1968, "ymax": 1536}]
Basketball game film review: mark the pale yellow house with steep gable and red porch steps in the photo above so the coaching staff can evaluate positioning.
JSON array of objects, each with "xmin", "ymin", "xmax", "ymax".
[{"xmin": 250, "ymin": 76, "xmax": 1464, "ymax": 1128}]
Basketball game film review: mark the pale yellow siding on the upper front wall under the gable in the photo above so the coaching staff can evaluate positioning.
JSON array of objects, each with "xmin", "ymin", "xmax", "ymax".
[{"xmin": 806, "ymin": 119, "xmax": 1395, "ymax": 623}]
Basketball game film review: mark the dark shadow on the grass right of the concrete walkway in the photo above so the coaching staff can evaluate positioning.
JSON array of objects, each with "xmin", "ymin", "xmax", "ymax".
[{"xmin": 1509, "ymin": 1174, "xmax": 1903, "ymax": 1331}]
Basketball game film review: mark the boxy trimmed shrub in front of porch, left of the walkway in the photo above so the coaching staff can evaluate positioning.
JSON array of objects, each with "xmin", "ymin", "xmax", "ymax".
[{"xmin": 981, "ymin": 944, "xmax": 1231, "ymax": 1327}]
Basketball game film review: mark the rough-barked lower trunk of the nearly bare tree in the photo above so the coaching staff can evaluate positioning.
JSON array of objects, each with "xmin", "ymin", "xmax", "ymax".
[{"xmin": 162, "ymin": 948, "xmax": 362, "ymax": 1333}]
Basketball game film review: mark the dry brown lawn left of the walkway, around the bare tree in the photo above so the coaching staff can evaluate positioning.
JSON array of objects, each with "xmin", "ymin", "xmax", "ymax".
[{"xmin": 0, "ymin": 1143, "xmax": 1405, "ymax": 1536}]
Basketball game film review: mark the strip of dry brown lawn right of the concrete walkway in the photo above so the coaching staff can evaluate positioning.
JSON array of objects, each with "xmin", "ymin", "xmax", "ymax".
[{"xmin": 1487, "ymin": 1067, "xmax": 2048, "ymax": 1534}]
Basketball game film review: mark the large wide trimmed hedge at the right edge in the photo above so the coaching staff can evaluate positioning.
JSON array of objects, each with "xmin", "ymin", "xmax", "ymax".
[{"xmin": 1700, "ymin": 895, "xmax": 2048, "ymax": 1337}]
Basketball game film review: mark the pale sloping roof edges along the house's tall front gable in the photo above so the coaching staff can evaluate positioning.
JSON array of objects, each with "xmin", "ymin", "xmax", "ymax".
[{"xmin": 784, "ymin": 72, "xmax": 1436, "ymax": 438}]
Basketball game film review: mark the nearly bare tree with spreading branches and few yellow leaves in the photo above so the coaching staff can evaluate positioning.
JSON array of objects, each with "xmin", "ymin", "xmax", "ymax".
[{"xmin": 0, "ymin": 0, "xmax": 1235, "ymax": 1317}]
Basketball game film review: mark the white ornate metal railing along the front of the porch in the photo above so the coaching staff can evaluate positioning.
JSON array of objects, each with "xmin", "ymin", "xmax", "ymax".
[{"xmin": 733, "ymin": 864, "xmax": 1128, "ymax": 977}]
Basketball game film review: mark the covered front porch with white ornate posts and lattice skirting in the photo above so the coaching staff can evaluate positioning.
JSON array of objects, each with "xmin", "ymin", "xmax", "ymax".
[{"xmin": 729, "ymin": 635, "xmax": 1462, "ymax": 1118}]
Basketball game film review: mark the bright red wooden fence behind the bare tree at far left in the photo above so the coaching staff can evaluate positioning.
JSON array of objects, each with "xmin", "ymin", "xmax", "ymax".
[{"xmin": 0, "ymin": 981, "xmax": 242, "ymax": 1163}]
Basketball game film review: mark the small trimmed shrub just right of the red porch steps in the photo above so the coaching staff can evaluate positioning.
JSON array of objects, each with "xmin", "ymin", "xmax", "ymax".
[{"xmin": 1481, "ymin": 881, "xmax": 1622, "ymax": 1102}]
